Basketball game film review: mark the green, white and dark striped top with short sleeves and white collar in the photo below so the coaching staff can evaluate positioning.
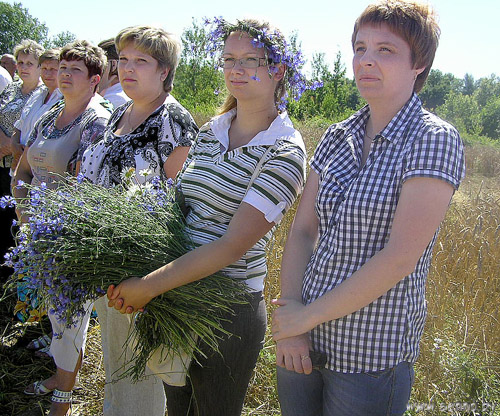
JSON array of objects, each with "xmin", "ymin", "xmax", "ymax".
[{"xmin": 180, "ymin": 110, "xmax": 306, "ymax": 291}]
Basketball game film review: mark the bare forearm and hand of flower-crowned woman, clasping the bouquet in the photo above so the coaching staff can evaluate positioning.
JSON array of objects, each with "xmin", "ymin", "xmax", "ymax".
[{"xmin": 108, "ymin": 202, "xmax": 274, "ymax": 313}]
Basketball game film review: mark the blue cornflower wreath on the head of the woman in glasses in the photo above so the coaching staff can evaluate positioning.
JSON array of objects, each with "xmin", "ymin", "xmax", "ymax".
[{"xmin": 204, "ymin": 17, "xmax": 323, "ymax": 111}]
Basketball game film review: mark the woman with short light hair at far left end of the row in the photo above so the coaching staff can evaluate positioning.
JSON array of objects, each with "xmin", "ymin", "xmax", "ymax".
[{"xmin": 0, "ymin": 40, "xmax": 43, "ymax": 279}]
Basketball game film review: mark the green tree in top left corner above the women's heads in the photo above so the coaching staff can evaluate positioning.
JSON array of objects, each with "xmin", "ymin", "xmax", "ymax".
[{"xmin": 0, "ymin": 2, "xmax": 48, "ymax": 54}]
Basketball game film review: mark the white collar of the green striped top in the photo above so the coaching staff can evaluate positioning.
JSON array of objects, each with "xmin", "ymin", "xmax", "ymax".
[{"xmin": 210, "ymin": 108, "xmax": 305, "ymax": 153}]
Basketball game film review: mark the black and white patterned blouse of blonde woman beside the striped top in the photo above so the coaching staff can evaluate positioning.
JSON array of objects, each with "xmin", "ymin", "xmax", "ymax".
[{"xmin": 81, "ymin": 95, "xmax": 198, "ymax": 187}]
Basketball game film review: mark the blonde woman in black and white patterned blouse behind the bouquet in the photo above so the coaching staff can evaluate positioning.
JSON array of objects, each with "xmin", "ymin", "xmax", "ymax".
[{"xmin": 82, "ymin": 26, "xmax": 198, "ymax": 416}]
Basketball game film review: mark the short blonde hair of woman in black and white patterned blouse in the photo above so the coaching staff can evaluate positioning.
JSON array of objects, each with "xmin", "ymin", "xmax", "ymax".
[{"xmin": 115, "ymin": 26, "xmax": 181, "ymax": 92}]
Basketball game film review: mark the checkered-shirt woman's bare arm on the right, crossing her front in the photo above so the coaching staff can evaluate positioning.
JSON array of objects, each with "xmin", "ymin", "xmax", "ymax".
[{"xmin": 272, "ymin": 178, "xmax": 453, "ymax": 340}]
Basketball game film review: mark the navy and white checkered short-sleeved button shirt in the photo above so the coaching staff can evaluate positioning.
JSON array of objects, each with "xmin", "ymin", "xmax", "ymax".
[{"xmin": 302, "ymin": 94, "xmax": 465, "ymax": 373}]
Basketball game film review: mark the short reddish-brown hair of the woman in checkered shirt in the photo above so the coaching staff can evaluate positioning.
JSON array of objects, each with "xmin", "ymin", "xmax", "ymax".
[{"xmin": 351, "ymin": 0, "xmax": 441, "ymax": 92}]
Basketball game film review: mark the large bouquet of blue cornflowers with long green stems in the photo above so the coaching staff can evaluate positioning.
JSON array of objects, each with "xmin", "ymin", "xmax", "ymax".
[{"xmin": 3, "ymin": 170, "xmax": 247, "ymax": 380}]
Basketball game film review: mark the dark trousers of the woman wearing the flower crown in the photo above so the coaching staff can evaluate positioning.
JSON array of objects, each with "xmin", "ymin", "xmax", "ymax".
[{"xmin": 164, "ymin": 292, "xmax": 266, "ymax": 416}]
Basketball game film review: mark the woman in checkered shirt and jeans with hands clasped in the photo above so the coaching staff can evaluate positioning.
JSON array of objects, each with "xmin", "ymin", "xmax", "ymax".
[{"xmin": 272, "ymin": 0, "xmax": 465, "ymax": 416}]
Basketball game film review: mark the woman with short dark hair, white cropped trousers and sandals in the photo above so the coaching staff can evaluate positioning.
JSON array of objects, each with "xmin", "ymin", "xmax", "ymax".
[{"xmin": 14, "ymin": 41, "xmax": 110, "ymax": 416}]
